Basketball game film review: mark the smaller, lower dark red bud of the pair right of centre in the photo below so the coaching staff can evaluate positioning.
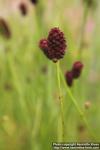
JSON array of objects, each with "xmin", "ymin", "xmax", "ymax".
[{"xmin": 65, "ymin": 71, "xmax": 73, "ymax": 86}]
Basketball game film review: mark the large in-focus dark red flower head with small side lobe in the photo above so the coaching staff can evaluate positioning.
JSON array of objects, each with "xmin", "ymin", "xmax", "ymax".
[{"xmin": 39, "ymin": 27, "xmax": 66, "ymax": 61}]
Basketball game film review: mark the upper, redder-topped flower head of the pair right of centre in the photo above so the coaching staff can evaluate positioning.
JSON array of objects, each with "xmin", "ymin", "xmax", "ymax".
[{"xmin": 72, "ymin": 61, "xmax": 83, "ymax": 78}]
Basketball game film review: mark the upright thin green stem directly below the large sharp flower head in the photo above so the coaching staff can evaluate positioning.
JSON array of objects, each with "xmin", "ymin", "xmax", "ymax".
[{"xmin": 56, "ymin": 61, "xmax": 65, "ymax": 142}]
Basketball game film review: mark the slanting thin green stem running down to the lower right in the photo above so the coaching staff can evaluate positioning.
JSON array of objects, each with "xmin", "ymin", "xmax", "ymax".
[{"xmin": 60, "ymin": 70, "xmax": 96, "ymax": 139}]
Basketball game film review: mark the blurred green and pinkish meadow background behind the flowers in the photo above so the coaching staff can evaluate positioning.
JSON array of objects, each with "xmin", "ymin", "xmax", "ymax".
[{"xmin": 0, "ymin": 0, "xmax": 100, "ymax": 150}]
